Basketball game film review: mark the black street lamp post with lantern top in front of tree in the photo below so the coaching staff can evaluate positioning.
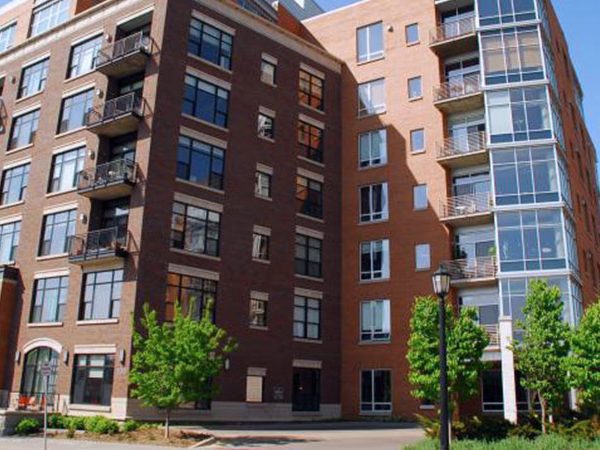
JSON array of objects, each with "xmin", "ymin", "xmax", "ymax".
[{"xmin": 432, "ymin": 266, "xmax": 450, "ymax": 450}]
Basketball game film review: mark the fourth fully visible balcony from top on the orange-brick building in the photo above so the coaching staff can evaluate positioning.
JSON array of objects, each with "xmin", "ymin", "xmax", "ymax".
[{"xmin": 440, "ymin": 192, "xmax": 494, "ymax": 226}]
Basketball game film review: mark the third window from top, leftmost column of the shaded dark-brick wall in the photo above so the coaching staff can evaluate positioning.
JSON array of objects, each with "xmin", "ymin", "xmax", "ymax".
[{"xmin": 177, "ymin": 136, "xmax": 225, "ymax": 190}]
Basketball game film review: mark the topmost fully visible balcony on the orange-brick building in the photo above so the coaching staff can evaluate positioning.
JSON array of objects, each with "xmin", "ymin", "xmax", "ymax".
[{"xmin": 429, "ymin": 16, "xmax": 477, "ymax": 57}]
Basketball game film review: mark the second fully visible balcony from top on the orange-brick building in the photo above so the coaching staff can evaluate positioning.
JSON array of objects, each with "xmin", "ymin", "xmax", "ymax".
[{"xmin": 433, "ymin": 74, "xmax": 483, "ymax": 113}]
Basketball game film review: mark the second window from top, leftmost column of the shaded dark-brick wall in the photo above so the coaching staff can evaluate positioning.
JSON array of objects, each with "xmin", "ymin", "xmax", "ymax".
[{"xmin": 183, "ymin": 75, "xmax": 229, "ymax": 128}]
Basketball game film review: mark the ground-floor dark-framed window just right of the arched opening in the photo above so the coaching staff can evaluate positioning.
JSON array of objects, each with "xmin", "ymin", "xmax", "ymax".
[{"xmin": 71, "ymin": 355, "xmax": 115, "ymax": 406}]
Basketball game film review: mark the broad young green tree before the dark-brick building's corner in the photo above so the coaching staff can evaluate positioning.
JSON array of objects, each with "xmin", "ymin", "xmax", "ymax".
[{"xmin": 129, "ymin": 305, "xmax": 236, "ymax": 438}]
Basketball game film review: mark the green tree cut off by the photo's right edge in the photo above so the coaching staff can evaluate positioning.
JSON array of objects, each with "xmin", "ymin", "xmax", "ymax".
[{"xmin": 567, "ymin": 300, "xmax": 600, "ymax": 412}]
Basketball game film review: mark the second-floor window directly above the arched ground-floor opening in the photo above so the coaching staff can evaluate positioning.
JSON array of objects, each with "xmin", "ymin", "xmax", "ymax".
[{"xmin": 30, "ymin": 276, "xmax": 69, "ymax": 323}]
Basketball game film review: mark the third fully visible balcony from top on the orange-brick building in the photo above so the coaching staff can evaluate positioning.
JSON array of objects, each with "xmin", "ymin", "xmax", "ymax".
[{"xmin": 437, "ymin": 131, "xmax": 489, "ymax": 169}]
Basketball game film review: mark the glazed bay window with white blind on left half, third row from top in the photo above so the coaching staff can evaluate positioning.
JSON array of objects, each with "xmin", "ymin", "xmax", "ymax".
[{"xmin": 487, "ymin": 87, "xmax": 552, "ymax": 144}]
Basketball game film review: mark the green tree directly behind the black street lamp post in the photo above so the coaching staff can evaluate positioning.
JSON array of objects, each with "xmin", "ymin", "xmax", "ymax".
[{"xmin": 407, "ymin": 297, "xmax": 489, "ymax": 410}]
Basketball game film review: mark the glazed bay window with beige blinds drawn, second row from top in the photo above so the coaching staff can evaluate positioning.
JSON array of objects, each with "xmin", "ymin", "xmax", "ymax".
[{"xmin": 481, "ymin": 26, "xmax": 544, "ymax": 85}]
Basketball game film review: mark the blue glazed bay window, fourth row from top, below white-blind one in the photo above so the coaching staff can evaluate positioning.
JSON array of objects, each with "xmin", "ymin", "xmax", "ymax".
[{"xmin": 492, "ymin": 147, "xmax": 560, "ymax": 206}]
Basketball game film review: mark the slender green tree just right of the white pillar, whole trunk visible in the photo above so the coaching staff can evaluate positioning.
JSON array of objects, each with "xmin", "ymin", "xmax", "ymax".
[{"xmin": 512, "ymin": 280, "xmax": 570, "ymax": 434}]
